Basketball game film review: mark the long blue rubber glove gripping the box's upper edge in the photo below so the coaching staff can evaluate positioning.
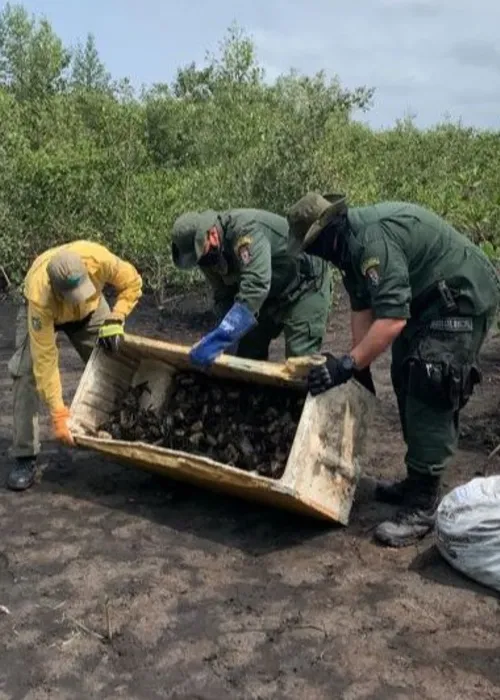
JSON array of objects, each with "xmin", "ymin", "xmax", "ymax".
[{"xmin": 189, "ymin": 303, "xmax": 257, "ymax": 367}]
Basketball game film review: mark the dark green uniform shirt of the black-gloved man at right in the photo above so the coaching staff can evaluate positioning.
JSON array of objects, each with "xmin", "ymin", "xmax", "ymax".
[{"xmin": 343, "ymin": 202, "xmax": 500, "ymax": 318}]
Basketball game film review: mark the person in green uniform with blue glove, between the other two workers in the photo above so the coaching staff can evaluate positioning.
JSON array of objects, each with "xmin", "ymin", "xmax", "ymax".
[{"xmin": 172, "ymin": 209, "xmax": 332, "ymax": 366}]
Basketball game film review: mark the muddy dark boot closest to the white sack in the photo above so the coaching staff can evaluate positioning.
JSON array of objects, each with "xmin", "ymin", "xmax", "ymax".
[{"xmin": 375, "ymin": 474, "xmax": 440, "ymax": 547}]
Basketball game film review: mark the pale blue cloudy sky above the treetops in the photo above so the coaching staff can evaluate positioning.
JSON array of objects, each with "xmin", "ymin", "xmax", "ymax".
[{"xmin": 17, "ymin": 0, "xmax": 500, "ymax": 128}]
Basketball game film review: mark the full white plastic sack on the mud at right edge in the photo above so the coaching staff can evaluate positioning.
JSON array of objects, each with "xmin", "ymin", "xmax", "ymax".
[{"xmin": 436, "ymin": 476, "xmax": 500, "ymax": 591}]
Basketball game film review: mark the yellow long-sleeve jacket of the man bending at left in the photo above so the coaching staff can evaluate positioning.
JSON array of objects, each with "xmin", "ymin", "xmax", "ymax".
[{"xmin": 24, "ymin": 241, "xmax": 142, "ymax": 411}]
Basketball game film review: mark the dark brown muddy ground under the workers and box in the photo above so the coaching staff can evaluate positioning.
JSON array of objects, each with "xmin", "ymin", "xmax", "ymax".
[{"xmin": 0, "ymin": 290, "xmax": 500, "ymax": 700}]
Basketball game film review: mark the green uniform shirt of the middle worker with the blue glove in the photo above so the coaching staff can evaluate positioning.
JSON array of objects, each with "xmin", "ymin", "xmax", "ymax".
[{"xmin": 202, "ymin": 209, "xmax": 330, "ymax": 314}]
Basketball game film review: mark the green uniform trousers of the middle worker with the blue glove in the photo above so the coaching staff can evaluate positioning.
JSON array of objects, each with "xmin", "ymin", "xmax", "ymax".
[{"xmin": 236, "ymin": 274, "xmax": 333, "ymax": 360}]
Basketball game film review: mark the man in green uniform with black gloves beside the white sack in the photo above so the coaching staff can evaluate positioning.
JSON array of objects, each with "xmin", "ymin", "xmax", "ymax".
[{"xmin": 287, "ymin": 193, "xmax": 500, "ymax": 546}]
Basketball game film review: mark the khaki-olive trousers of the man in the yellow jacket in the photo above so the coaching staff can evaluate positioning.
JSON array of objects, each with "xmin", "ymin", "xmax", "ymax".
[{"xmin": 8, "ymin": 297, "xmax": 109, "ymax": 457}]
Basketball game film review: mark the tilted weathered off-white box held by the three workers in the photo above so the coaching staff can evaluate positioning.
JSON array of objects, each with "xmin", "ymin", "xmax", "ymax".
[{"xmin": 71, "ymin": 334, "xmax": 374, "ymax": 525}]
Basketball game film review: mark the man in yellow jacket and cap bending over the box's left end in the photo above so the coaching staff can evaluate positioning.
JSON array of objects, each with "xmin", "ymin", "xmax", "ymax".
[{"xmin": 7, "ymin": 241, "xmax": 142, "ymax": 491}]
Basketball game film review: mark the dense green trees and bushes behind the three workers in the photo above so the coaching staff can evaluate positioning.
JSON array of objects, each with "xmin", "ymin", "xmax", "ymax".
[{"xmin": 0, "ymin": 5, "xmax": 500, "ymax": 297}]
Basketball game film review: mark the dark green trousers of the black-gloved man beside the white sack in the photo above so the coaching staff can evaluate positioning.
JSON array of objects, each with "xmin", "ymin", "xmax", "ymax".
[{"xmin": 391, "ymin": 313, "xmax": 494, "ymax": 476}]
